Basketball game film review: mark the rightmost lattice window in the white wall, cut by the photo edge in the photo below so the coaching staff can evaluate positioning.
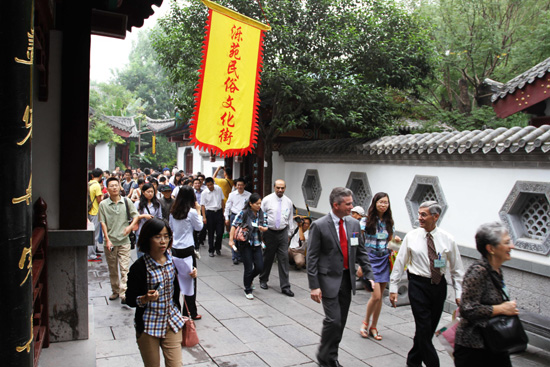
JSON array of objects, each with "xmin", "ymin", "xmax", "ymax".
[{"xmin": 499, "ymin": 181, "xmax": 550, "ymax": 255}]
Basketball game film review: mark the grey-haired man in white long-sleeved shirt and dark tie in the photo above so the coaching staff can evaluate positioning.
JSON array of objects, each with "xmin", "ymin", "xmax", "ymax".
[{"xmin": 390, "ymin": 201, "xmax": 464, "ymax": 367}]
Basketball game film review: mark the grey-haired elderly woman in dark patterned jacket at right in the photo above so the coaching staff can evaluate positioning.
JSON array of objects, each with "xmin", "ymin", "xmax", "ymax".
[{"xmin": 454, "ymin": 222, "xmax": 519, "ymax": 367}]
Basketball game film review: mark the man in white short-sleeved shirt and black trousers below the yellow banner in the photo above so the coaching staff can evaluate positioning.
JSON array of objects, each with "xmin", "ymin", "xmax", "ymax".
[{"xmin": 201, "ymin": 177, "xmax": 224, "ymax": 257}]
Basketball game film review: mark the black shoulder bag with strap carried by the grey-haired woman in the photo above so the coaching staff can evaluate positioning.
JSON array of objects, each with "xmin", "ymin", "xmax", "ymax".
[{"xmin": 481, "ymin": 269, "xmax": 529, "ymax": 353}]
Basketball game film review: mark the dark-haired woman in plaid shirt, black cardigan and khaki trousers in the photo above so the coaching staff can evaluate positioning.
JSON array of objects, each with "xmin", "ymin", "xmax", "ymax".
[{"xmin": 126, "ymin": 218, "xmax": 197, "ymax": 367}]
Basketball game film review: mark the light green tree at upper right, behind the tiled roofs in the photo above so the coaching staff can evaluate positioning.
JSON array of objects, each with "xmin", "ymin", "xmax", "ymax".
[{"xmin": 416, "ymin": 0, "xmax": 550, "ymax": 122}]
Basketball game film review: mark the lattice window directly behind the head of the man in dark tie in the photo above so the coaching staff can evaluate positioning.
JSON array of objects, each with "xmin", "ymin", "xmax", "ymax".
[{"xmin": 405, "ymin": 175, "xmax": 447, "ymax": 228}]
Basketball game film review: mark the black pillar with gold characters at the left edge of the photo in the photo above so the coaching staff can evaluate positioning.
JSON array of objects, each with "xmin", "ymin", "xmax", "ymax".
[{"xmin": 0, "ymin": 0, "xmax": 34, "ymax": 367}]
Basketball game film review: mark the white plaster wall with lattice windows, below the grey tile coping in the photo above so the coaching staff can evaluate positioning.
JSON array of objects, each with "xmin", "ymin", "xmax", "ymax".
[{"xmin": 283, "ymin": 162, "xmax": 550, "ymax": 265}]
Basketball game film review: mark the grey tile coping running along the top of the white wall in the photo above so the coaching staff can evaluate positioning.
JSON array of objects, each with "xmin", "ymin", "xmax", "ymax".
[{"xmin": 279, "ymin": 125, "xmax": 550, "ymax": 156}]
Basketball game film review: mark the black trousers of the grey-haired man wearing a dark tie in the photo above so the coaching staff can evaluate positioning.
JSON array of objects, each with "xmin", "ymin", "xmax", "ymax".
[{"xmin": 407, "ymin": 273, "xmax": 447, "ymax": 367}]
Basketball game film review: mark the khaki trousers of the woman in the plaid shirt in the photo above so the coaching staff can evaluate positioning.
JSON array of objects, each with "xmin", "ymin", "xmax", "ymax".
[{"xmin": 137, "ymin": 328, "xmax": 182, "ymax": 367}]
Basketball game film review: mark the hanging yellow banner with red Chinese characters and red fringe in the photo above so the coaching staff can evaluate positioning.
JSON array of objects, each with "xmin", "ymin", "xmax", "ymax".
[{"xmin": 191, "ymin": 0, "xmax": 270, "ymax": 156}]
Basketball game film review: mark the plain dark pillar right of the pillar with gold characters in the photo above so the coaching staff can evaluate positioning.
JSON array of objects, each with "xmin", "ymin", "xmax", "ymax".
[{"xmin": 59, "ymin": 0, "xmax": 92, "ymax": 229}]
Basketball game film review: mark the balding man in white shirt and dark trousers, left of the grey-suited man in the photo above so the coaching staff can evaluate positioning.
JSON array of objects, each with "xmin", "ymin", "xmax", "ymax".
[{"xmin": 260, "ymin": 180, "xmax": 294, "ymax": 297}]
